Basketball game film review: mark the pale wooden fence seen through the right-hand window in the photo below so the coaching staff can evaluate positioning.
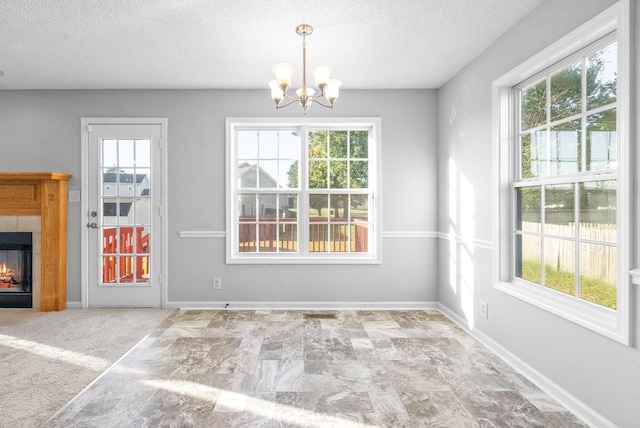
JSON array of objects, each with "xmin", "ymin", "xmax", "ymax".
[{"xmin": 522, "ymin": 222, "xmax": 618, "ymax": 284}]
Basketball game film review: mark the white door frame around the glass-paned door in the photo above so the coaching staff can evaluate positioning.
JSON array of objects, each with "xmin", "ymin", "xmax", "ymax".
[{"xmin": 80, "ymin": 117, "xmax": 169, "ymax": 309}]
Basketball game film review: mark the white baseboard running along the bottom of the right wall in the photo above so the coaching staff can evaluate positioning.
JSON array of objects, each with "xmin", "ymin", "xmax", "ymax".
[{"xmin": 438, "ymin": 303, "xmax": 616, "ymax": 428}]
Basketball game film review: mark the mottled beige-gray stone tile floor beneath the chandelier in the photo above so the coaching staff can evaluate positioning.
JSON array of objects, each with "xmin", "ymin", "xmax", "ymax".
[{"xmin": 45, "ymin": 310, "xmax": 585, "ymax": 428}]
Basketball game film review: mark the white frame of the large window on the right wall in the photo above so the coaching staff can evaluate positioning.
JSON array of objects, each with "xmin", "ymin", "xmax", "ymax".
[{"xmin": 492, "ymin": 0, "xmax": 634, "ymax": 345}]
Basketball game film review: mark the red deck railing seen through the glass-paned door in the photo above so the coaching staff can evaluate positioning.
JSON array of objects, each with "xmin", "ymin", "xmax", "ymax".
[{"xmin": 102, "ymin": 226, "xmax": 150, "ymax": 283}]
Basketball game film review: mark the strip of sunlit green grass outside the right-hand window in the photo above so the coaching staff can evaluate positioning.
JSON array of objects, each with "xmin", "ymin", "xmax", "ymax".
[{"xmin": 522, "ymin": 260, "xmax": 617, "ymax": 309}]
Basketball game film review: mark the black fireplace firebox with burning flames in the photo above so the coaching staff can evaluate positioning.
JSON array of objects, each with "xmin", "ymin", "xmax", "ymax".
[{"xmin": 0, "ymin": 232, "xmax": 33, "ymax": 308}]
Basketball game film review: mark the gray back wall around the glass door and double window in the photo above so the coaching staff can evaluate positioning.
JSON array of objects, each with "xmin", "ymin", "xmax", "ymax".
[{"xmin": 0, "ymin": 89, "xmax": 437, "ymax": 305}]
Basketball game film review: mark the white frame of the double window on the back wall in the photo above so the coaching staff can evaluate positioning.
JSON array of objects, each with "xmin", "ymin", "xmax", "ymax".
[{"xmin": 226, "ymin": 117, "xmax": 382, "ymax": 264}]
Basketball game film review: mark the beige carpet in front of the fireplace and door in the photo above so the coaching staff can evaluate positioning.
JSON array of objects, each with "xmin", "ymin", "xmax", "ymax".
[{"xmin": 0, "ymin": 308, "xmax": 172, "ymax": 428}]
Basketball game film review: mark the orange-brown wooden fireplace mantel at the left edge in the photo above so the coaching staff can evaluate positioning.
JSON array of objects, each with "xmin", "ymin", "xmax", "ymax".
[{"xmin": 0, "ymin": 172, "xmax": 71, "ymax": 312}]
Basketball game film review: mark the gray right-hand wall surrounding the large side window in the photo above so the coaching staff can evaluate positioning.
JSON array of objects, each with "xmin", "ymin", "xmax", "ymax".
[{"xmin": 438, "ymin": 0, "xmax": 640, "ymax": 427}]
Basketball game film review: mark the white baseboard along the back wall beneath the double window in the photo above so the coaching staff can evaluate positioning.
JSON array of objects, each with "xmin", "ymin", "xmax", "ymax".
[{"xmin": 167, "ymin": 301, "xmax": 438, "ymax": 310}]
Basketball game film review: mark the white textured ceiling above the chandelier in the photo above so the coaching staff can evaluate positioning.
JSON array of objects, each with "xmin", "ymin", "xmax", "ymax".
[{"xmin": 0, "ymin": 0, "xmax": 541, "ymax": 89}]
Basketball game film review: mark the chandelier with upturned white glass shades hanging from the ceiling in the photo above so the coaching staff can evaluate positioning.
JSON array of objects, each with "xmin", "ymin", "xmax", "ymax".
[{"xmin": 269, "ymin": 24, "xmax": 342, "ymax": 115}]
